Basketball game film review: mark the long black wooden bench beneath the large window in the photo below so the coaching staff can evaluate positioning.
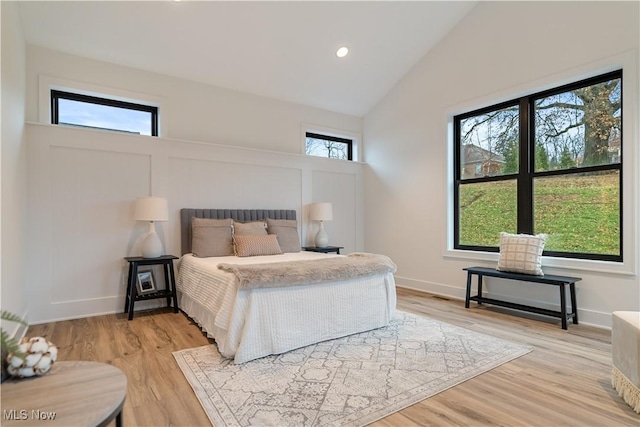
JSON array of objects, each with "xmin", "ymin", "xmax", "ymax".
[{"xmin": 463, "ymin": 267, "xmax": 581, "ymax": 329}]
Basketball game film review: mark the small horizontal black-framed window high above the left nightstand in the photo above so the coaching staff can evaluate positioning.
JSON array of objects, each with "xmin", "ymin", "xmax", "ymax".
[{"xmin": 51, "ymin": 90, "xmax": 158, "ymax": 136}]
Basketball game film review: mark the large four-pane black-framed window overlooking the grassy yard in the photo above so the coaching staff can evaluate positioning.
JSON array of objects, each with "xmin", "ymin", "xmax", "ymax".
[{"xmin": 454, "ymin": 70, "xmax": 623, "ymax": 261}]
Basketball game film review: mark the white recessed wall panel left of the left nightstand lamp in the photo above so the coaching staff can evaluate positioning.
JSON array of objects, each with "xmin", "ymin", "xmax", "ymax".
[{"xmin": 50, "ymin": 147, "xmax": 151, "ymax": 304}]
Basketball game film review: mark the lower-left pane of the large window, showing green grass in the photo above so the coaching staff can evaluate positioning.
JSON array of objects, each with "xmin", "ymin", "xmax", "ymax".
[{"xmin": 460, "ymin": 180, "xmax": 518, "ymax": 247}]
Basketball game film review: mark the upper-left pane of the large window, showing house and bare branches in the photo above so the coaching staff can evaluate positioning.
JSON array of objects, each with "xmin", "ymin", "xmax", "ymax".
[{"xmin": 459, "ymin": 106, "xmax": 519, "ymax": 179}]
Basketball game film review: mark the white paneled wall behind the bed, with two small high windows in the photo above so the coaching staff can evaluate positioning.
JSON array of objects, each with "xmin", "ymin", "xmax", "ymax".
[{"xmin": 26, "ymin": 47, "xmax": 364, "ymax": 323}]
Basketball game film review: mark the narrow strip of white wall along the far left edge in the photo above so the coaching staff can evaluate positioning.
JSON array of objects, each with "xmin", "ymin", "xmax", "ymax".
[{"xmin": 0, "ymin": 2, "xmax": 27, "ymax": 334}]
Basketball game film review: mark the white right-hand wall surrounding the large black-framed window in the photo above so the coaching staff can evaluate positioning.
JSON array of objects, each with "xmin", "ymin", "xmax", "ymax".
[{"xmin": 363, "ymin": 2, "xmax": 640, "ymax": 326}]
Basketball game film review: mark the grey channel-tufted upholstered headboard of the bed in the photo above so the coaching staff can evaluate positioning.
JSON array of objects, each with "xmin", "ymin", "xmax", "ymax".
[{"xmin": 180, "ymin": 208, "xmax": 296, "ymax": 255}]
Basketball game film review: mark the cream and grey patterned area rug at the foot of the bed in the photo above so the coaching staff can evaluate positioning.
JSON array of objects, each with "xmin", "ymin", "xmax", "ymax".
[{"xmin": 173, "ymin": 311, "xmax": 531, "ymax": 427}]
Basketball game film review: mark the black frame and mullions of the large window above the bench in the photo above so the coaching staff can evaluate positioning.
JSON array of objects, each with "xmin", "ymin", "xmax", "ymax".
[{"xmin": 453, "ymin": 69, "xmax": 624, "ymax": 262}]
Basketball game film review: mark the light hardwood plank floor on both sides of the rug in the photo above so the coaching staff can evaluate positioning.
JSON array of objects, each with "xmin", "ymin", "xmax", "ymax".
[{"xmin": 28, "ymin": 289, "xmax": 640, "ymax": 427}]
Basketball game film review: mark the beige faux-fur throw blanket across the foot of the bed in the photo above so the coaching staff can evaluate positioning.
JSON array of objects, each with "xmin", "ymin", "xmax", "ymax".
[{"xmin": 218, "ymin": 252, "xmax": 396, "ymax": 289}]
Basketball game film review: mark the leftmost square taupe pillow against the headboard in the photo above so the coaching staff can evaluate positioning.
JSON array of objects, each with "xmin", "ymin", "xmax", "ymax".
[{"xmin": 191, "ymin": 218, "xmax": 234, "ymax": 258}]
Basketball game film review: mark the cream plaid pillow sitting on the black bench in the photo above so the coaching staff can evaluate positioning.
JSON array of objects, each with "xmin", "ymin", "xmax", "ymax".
[{"xmin": 497, "ymin": 232, "xmax": 547, "ymax": 276}]
